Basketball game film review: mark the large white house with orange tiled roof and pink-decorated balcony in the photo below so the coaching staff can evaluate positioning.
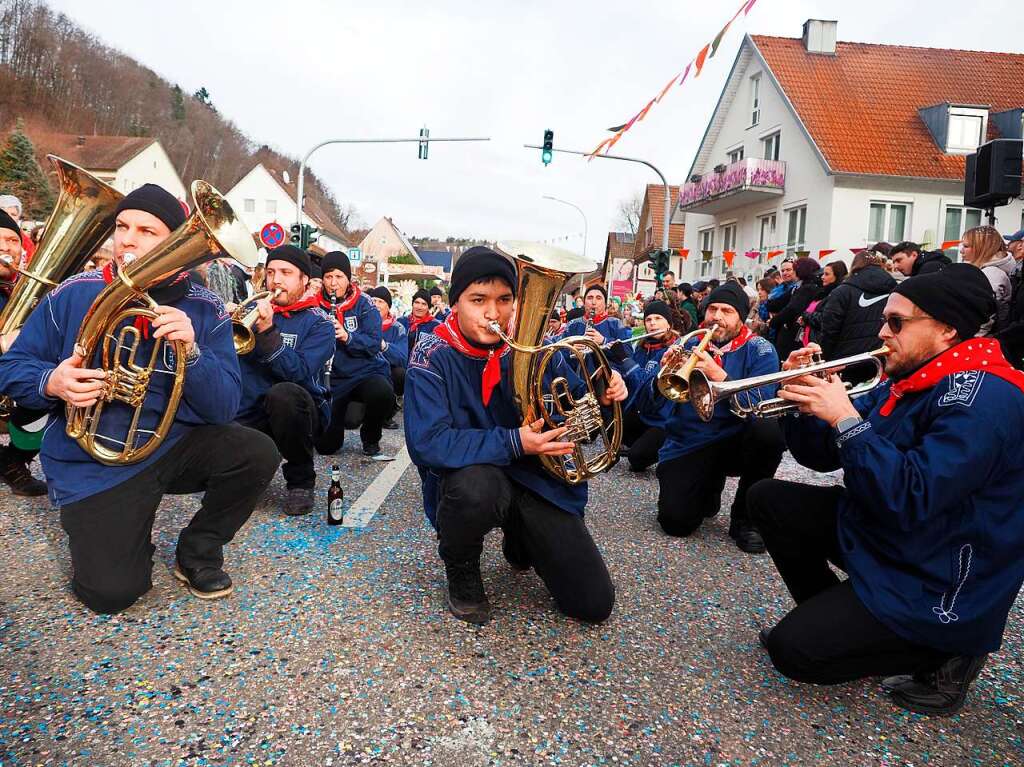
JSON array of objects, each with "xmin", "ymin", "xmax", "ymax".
[{"xmin": 672, "ymin": 19, "xmax": 1024, "ymax": 282}]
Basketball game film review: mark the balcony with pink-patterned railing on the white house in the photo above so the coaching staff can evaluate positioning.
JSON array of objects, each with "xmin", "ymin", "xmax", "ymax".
[{"xmin": 679, "ymin": 158, "xmax": 785, "ymax": 215}]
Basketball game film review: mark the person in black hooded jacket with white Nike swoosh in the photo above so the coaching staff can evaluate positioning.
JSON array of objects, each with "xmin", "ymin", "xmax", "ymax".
[{"xmin": 817, "ymin": 251, "xmax": 896, "ymax": 383}]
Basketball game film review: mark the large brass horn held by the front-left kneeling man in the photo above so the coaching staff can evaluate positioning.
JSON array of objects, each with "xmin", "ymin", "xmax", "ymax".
[{"xmin": 67, "ymin": 181, "xmax": 259, "ymax": 466}]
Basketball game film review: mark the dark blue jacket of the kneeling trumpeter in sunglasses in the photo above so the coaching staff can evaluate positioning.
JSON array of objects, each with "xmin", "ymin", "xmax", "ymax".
[{"xmin": 784, "ymin": 364, "xmax": 1024, "ymax": 655}]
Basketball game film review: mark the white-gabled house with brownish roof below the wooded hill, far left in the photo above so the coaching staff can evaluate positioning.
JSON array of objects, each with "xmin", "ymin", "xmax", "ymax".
[{"xmin": 33, "ymin": 133, "xmax": 187, "ymax": 200}]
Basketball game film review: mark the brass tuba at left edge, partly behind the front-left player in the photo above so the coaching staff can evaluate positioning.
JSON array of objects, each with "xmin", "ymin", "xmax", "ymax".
[{"xmin": 0, "ymin": 155, "xmax": 124, "ymax": 418}]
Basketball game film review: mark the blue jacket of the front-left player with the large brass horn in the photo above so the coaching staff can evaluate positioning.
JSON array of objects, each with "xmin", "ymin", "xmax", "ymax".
[{"xmin": 0, "ymin": 271, "xmax": 242, "ymax": 506}]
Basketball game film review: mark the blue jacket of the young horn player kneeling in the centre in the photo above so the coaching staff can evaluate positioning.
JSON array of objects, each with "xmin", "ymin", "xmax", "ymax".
[{"xmin": 404, "ymin": 334, "xmax": 587, "ymax": 526}]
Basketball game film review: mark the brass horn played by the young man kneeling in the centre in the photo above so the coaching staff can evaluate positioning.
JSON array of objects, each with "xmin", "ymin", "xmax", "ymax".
[{"xmin": 492, "ymin": 242, "xmax": 623, "ymax": 484}]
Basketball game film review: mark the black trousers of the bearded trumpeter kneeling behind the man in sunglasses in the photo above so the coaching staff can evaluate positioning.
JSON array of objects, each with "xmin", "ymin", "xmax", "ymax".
[{"xmin": 655, "ymin": 419, "xmax": 785, "ymax": 536}]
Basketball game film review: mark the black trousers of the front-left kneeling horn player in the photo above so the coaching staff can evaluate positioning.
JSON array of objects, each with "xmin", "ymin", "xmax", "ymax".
[{"xmin": 60, "ymin": 424, "xmax": 281, "ymax": 613}]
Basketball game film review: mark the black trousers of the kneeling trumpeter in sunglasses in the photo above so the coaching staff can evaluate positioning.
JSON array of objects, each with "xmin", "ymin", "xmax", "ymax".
[{"xmin": 748, "ymin": 479, "xmax": 949, "ymax": 684}]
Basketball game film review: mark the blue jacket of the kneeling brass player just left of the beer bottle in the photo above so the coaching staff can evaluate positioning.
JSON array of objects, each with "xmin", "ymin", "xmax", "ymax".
[{"xmin": 239, "ymin": 307, "xmax": 335, "ymax": 425}]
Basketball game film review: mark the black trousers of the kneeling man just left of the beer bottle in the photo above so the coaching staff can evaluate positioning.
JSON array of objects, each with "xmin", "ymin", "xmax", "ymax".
[{"xmin": 239, "ymin": 381, "xmax": 322, "ymax": 488}]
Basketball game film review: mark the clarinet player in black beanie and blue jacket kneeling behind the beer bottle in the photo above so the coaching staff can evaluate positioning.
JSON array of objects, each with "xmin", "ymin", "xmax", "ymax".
[{"xmin": 316, "ymin": 251, "xmax": 397, "ymax": 458}]
